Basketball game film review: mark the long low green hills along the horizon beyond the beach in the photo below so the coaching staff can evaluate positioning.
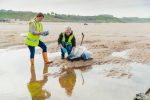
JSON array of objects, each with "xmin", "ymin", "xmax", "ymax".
[{"xmin": 0, "ymin": 10, "xmax": 150, "ymax": 23}]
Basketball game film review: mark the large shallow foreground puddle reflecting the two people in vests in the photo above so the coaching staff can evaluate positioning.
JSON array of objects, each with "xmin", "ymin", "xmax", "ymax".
[{"xmin": 0, "ymin": 49, "xmax": 150, "ymax": 100}]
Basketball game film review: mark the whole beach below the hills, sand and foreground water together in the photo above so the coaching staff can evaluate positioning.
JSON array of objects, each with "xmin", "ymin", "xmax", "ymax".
[{"xmin": 0, "ymin": 22, "xmax": 150, "ymax": 100}]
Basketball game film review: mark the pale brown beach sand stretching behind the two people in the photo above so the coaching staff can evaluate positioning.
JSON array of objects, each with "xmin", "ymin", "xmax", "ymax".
[{"xmin": 0, "ymin": 22, "xmax": 150, "ymax": 64}]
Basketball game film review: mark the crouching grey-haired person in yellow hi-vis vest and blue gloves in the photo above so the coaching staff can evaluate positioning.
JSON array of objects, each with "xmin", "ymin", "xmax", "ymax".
[{"xmin": 58, "ymin": 27, "xmax": 76, "ymax": 59}]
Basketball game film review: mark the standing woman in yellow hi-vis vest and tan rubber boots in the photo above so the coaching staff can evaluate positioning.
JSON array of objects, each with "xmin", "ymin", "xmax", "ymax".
[{"xmin": 25, "ymin": 13, "xmax": 52, "ymax": 65}]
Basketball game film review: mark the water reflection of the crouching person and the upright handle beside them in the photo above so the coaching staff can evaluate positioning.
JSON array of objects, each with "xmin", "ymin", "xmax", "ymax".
[{"xmin": 45, "ymin": 66, "xmax": 92, "ymax": 96}]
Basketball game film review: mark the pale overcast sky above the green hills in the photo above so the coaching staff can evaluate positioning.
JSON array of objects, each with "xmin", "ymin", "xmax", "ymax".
[{"xmin": 0, "ymin": 0, "xmax": 150, "ymax": 17}]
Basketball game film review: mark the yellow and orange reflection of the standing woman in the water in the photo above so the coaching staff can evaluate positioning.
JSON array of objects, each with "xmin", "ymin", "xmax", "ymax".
[{"xmin": 27, "ymin": 65, "xmax": 51, "ymax": 100}]
